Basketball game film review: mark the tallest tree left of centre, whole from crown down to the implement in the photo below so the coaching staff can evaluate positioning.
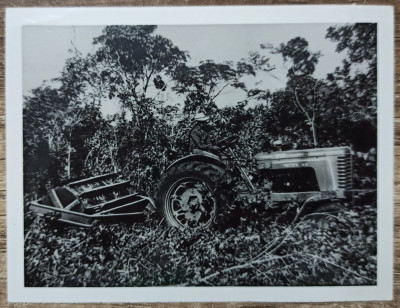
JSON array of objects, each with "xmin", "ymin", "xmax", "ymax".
[{"xmin": 81, "ymin": 26, "xmax": 191, "ymax": 190}]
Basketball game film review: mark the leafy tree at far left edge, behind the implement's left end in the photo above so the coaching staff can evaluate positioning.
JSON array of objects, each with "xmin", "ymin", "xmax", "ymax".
[{"xmin": 23, "ymin": 42, "xmax": 112, "ymax": 194}]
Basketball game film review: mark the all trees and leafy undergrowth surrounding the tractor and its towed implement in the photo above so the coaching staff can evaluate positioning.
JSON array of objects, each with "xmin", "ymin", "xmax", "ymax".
[{"xmin": 23, "ymin": 24, "xmax": 377, "ymax": 286}]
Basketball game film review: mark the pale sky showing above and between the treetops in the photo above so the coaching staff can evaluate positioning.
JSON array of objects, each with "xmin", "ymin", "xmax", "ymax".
[{"xmin": 23, "ymin": 24, "xmax": 344, "ymax": 114}]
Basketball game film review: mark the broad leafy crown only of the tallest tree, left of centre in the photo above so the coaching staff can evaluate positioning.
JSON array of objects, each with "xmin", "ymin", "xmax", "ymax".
[{"xmin": 93, "ymin": 26, "xmax": 187, "ymax": 118}]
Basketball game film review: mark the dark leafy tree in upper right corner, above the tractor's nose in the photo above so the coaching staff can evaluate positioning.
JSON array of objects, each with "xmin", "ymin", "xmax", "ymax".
[{"xmin": 326, "ymin": 23, "xmax": 377, "ymax": 151}]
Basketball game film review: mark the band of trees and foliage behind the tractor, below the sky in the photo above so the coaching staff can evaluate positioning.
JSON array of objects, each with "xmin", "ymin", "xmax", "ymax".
[{"xmin": 23, "ymin": 24, "xmax": 377, "ymax": 200}]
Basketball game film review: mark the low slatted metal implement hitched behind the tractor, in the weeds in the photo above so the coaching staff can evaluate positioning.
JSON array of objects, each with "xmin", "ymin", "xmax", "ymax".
[{"xmin": 30, "ymin": 173, "xmax": 154, "ymax": 227}]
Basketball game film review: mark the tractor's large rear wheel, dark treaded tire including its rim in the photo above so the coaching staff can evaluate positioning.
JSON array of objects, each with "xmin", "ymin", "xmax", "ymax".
[{"xmin": 155, "ymin": 161, "xmax": 224, "ymax": 229}]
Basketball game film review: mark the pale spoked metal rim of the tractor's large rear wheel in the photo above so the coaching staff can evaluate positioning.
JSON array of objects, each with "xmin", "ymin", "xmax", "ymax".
[{"xmin": 165, "ymin": 178, "xmax": 217, "ymax": 228}]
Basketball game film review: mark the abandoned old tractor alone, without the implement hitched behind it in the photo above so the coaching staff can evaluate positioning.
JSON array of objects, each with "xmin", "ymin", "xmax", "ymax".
[{"xmin": 155, "ymin": 137, "xmax": 352, "ymax": 229}]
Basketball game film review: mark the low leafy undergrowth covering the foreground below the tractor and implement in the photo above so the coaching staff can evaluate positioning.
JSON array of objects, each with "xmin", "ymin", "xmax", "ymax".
[{"xmin": 25, "ymin": 200, "xmax": 377, "ymax": 287}]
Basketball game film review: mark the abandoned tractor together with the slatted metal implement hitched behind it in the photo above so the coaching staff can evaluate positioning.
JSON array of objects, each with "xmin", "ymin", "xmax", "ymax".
[{"xmin": 30, "ymin": 137, "xmax": 352, "ymax": 229}]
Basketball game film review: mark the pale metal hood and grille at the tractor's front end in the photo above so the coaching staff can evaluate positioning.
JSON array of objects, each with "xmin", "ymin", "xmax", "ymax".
[{"xmin": 254, "ymin": 147, "xmax": 352, "ymax": 201}]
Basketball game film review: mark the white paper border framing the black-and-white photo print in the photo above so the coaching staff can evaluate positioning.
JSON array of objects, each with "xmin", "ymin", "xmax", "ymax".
[{"xmin": 6, "ymin": 5, "xmax": 394, "ymax": 303}]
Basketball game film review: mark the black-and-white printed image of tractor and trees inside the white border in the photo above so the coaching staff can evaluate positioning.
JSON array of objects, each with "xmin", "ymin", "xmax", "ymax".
[{"xmin": 9, "ymin": 4, "xmax": 392, "ymax": 300}]
